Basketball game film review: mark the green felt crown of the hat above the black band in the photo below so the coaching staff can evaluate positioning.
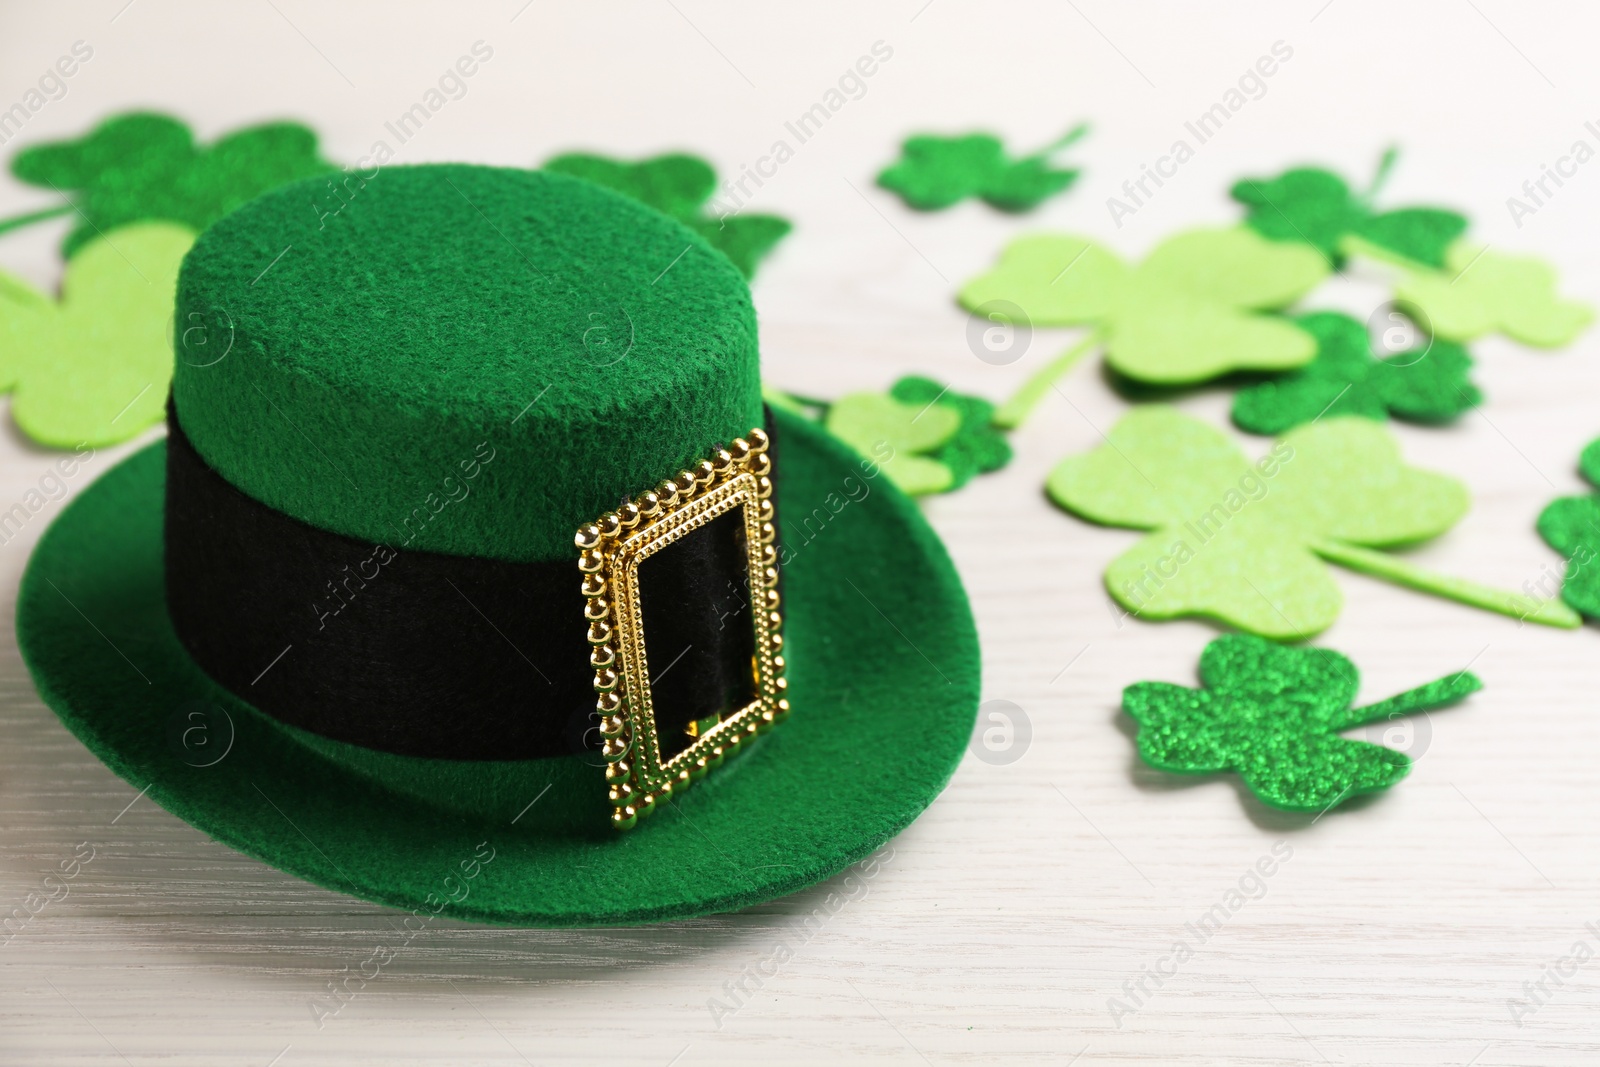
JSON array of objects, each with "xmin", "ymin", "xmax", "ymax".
[{"xmin": 173, "ymin": 165, "xmax": 762, "ymax": 560}]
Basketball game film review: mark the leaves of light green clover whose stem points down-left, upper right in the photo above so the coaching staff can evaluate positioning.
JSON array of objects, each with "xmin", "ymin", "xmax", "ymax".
[{"xmin": 960, "ymin": 229, "xmax": 1328, "ymax": 386}]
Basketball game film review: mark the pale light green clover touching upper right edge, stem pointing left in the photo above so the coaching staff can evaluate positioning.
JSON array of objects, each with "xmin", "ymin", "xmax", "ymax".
[{"xmin": 1344, "ymin": 238, "xmax": 1594, "ymax": 349}]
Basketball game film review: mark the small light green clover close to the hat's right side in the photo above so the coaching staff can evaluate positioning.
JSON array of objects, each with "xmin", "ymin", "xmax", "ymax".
[{"xmin": 826, "ymin": 392, "xmax": 962, "ymax": 496}]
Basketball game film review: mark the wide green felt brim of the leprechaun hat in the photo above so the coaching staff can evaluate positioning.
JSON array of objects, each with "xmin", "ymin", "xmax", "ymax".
[{"xmin": 16, "ymin": 413, "xmax": 979, "ymax": 926}]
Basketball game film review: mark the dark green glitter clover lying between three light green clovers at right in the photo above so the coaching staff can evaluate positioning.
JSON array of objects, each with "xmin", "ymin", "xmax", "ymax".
[{"xmin": 1234, "ymin": 312, "xmax": 1483, "ymax": 434}]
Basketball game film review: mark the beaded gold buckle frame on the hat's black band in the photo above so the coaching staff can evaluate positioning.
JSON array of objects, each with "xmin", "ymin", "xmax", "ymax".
[{"xmin": 574, "ymin": 427, "xmax": 789, "ymax": 830}]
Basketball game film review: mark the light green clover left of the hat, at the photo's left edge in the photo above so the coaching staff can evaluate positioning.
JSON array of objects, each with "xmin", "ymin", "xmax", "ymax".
[{"xmin": 0, "ymin": 222, "xmax": 194, "ymax": 448}]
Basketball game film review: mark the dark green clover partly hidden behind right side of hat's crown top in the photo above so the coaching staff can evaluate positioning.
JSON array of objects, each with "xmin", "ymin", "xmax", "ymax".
[{"xmin": 544, "ymin": 152, "xmax": 794, "ymax": 278}]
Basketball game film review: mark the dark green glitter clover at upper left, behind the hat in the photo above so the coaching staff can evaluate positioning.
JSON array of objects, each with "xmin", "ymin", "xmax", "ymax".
[{"xmin": 11, "ymin": 112, "xmax": 336, "ymax": 256}]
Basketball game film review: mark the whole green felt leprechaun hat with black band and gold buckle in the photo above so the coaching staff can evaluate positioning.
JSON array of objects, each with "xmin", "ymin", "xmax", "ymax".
[{"xmin": 18, "ymin": 165, "xmax": 979, "ymax": 926}]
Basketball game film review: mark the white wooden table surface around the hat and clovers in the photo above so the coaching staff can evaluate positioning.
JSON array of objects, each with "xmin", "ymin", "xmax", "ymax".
[{"xmin": 0, "ymin": 0, "xmax": 1600, "ymax": 1067}]
